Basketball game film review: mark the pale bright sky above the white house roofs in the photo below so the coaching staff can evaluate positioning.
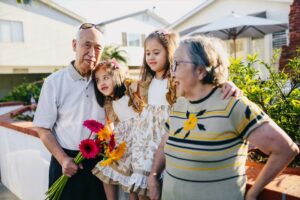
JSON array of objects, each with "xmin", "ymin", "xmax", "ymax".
[{"xmin": 52, "ymin": 0, "xmax": 204, "ymax": 23}]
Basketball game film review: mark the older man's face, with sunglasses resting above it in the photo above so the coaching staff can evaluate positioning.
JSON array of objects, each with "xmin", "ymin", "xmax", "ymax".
[{"xmin": 73, "ymin": 28, "xmax": 104, "ymax": 76}]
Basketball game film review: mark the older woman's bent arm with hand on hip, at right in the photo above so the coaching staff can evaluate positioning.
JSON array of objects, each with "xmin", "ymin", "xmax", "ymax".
[{"xmin": 246, "ymin": 122, "xmax": 299, "ymax": 200}]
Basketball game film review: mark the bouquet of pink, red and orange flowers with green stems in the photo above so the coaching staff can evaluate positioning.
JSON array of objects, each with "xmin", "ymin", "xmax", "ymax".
[{"xmin": 46, "ymin": 120, "xmax": 126, "ymax": 200}]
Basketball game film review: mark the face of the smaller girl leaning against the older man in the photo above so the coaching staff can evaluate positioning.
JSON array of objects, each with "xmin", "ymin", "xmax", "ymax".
[{"xmin": 95, "ymin": 66, "xmax": 114, "ymax": 96}]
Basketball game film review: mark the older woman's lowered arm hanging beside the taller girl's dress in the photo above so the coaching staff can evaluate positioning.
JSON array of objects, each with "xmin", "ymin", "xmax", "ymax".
[{"xmin": 148, "ymin": 133, "xmax": 169, "ymax": 200}]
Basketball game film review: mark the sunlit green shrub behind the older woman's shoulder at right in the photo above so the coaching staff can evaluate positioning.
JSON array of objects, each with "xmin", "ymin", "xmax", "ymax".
[{"xmin": 229, "ymin": 49, "xmax": 300, "ymax": 142}]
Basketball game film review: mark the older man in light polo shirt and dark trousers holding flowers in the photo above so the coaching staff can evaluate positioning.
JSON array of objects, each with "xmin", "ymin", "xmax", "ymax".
[{"xmin": 33, "ymin": 23, "xmax": 105, "ymax": 200}]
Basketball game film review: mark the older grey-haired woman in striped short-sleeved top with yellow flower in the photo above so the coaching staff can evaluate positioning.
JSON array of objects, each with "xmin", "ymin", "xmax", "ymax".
[{"xmin": 149, "ymin": 36, "xmax": 299, "ymax": 200}]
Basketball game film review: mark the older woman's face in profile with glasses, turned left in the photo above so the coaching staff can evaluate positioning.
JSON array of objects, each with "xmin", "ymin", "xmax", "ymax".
[{"xmin": 172, "ymin": 44, "xmax": 200, "ymax": 95}]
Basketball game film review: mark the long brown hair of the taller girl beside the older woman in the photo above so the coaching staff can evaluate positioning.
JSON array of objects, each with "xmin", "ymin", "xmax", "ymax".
[{"xmin": 140, "ymin": 30, "xmax": 179, "ymax": 81}]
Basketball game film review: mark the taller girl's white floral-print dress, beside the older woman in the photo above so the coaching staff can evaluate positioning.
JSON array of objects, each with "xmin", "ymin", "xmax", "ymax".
[{"xmin": 127, "ymin": 78, "xmax": 170, "ymax": 195}]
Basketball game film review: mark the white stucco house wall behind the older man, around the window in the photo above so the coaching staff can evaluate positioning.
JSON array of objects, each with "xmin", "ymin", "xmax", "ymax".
[{"xmin": 0, "ymin": 0, "xmax": 80, "ymax": 73}]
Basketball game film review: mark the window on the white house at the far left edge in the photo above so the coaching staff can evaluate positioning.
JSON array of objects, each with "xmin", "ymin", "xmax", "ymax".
[{"xmin": 0, "ymin": 20, "xmax": 24, "ymax": 42}]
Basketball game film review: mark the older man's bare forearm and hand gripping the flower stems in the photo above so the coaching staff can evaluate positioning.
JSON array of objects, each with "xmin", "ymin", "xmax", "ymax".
[{"xmin": 35, "ymin": 127, "xmax": 78, "ymax": 177}]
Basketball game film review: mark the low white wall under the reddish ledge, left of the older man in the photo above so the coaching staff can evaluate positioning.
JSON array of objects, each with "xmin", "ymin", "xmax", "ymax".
[{"xmin": 0, "ymin": 126, "xmax": 50, "ymax": 200}]
